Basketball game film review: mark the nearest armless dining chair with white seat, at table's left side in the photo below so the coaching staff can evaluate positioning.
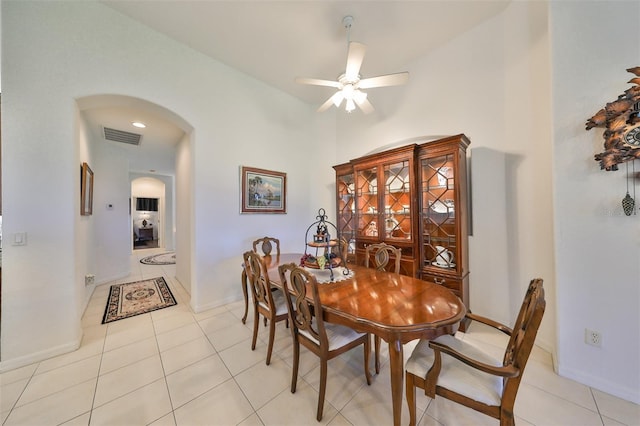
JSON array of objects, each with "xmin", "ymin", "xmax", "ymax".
[{"xmin": 278, "ymin": 263, "xmax": 371, "ymax": 421}]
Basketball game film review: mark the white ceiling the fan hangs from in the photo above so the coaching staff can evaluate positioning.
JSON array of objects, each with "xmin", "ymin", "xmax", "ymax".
[{"xmin": 85, "ymin": 0, "xmax": 511, "ymax": 173}]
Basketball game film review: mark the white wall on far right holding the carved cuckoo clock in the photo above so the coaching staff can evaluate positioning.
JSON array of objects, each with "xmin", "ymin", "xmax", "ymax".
[{"xmin": 551, "ymin": 1, "xmax": 640, "ymax": 403}]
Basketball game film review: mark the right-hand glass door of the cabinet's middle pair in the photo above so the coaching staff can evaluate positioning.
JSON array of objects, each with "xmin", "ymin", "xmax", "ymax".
[{"xmin": 382, "ymin": 160, "xmax": 411, "ymax": 244}]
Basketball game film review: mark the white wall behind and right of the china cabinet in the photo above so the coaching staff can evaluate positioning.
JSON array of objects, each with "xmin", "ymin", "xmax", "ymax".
[{"xmin": 338, "ymin": 2, "xmax": 555, "ymax": 350}]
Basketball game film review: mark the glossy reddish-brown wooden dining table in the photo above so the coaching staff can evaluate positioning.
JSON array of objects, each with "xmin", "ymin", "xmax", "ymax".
[{"xmin": 265, "ymin": 253, "xmax": 466, "ymax": 425}]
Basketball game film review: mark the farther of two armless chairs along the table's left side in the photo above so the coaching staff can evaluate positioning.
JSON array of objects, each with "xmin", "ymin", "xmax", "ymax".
[{"xmin": 243, "ymin": 251, "xmax": 288, "ymax": 365}]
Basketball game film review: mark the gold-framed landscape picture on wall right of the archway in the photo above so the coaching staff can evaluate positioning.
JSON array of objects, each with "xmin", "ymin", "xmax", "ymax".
[{"xmin": 240, "ymin": 166, "xmax": 287, "ymax": 213}]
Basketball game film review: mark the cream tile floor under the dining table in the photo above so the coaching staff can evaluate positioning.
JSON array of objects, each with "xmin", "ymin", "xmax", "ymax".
[{"xmin": 0, "ymin": 249, "xmax": 640, "ymax": 426}]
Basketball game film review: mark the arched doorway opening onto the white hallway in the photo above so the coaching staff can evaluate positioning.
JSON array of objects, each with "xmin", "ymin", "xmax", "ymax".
[{"xmin": 77, "ymin": 95, "xmax": 193, "ymax": 287}]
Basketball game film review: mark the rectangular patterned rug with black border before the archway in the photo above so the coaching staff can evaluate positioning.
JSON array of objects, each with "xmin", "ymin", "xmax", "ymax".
[{"xmin": 102, "ymin": 277, "xmax": 178, "ymax": 324}]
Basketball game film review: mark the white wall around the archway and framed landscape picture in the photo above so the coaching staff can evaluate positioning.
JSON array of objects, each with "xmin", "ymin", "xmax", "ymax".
[{"xmin": 1, "ymin": 2, "xmax": 320, "ymax": 368}]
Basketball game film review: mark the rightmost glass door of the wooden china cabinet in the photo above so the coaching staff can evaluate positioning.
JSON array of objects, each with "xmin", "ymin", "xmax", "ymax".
[{"xmin": 419, "ymin": 154, "xmax": 458, "ymax": 270}]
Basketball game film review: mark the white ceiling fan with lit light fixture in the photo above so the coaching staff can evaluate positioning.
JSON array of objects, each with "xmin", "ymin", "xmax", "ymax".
[{"xmin": 296, "ymin": 16, "xmax": 409, "ymax": 114}]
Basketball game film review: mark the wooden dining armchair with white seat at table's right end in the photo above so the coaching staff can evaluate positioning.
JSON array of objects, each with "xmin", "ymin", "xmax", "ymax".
[{"xmin": 406, "ymin": 278, "xmax": 546, "ymax": 426}]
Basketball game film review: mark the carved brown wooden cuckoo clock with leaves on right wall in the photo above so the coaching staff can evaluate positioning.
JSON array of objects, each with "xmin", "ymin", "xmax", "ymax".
[{"xmin": 586, "ymin": 66, "xmax": 640, "ymax": 170}]
